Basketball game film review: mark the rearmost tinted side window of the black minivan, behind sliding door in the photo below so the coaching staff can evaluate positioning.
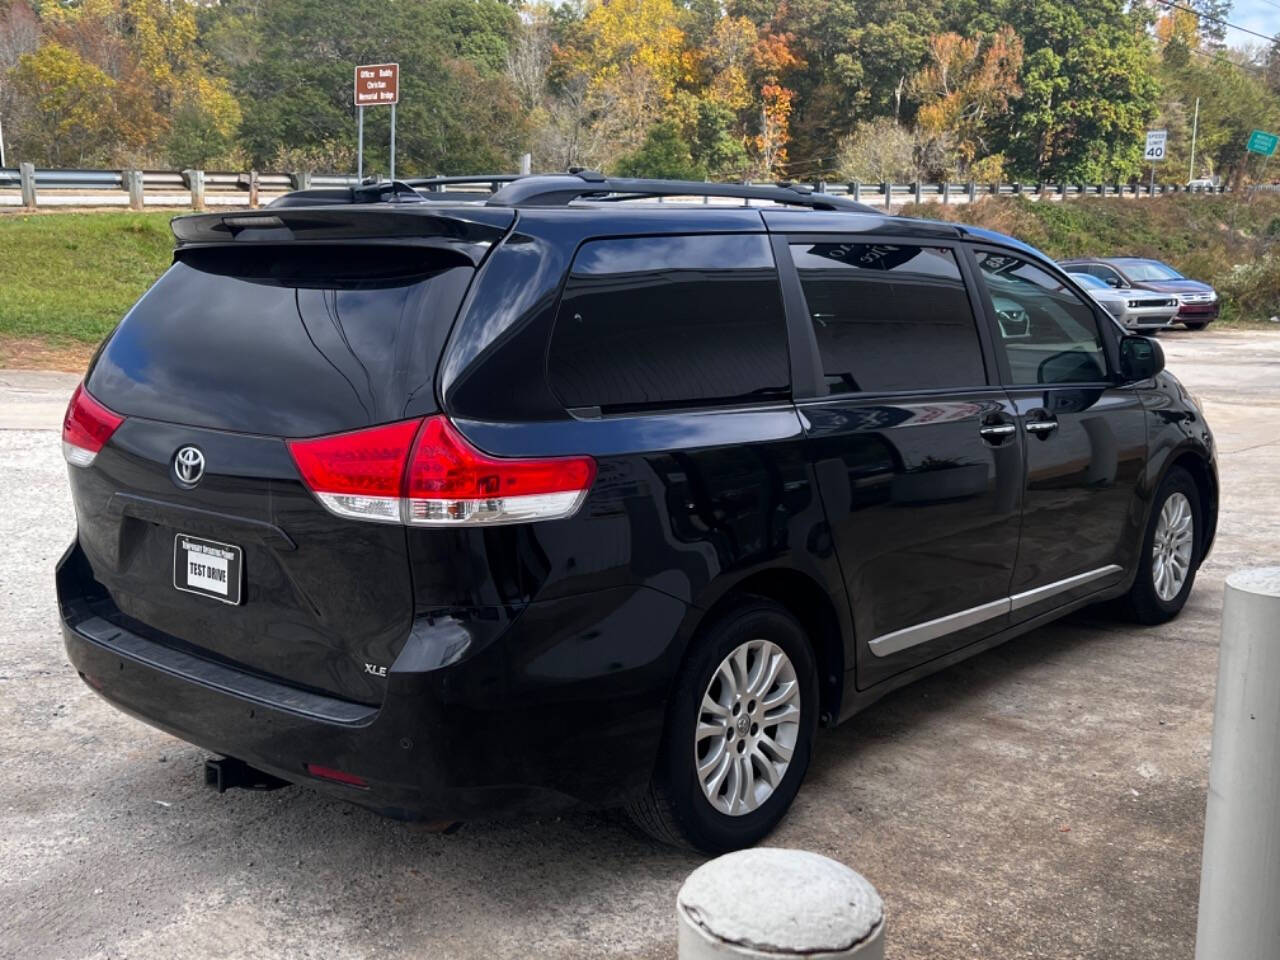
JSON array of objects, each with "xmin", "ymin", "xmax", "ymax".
[{"xmin": 548, "ymin": 234, "xmax": 791, "ymax": 412}]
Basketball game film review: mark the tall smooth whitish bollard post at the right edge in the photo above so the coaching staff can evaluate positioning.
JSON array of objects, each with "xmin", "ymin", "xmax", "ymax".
[{"xmin": 1196, "ymin": 567, "xmax": 1280, "ymax": 960}]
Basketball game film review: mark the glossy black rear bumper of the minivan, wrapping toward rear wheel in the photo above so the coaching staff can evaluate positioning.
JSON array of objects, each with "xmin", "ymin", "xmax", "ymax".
[{"xmin": 58, "ymin": 544, "xmax": 686, "ymax": 820}]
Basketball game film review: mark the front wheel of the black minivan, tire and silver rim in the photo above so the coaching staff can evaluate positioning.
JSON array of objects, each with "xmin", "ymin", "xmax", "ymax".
[{"xmin": 1125, "ymin": 467, "xmax": 1203, "ymax": 623}]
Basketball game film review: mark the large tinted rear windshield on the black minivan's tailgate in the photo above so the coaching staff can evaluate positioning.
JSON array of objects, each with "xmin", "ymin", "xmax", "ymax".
[{"xmin": 88, "ymin": 246, "xmax": 474, "ymax": 436}]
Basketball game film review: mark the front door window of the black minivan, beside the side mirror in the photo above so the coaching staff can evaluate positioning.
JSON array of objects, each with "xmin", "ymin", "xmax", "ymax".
[{"xmin": 977, "ymin": 251, "xmax": 1107, "ymax": 384}]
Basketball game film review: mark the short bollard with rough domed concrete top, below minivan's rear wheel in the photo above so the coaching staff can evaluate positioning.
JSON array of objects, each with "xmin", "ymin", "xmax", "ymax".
[{"xmin": 676, "ymin": 847, "xmax": 884, "ymax": 960}]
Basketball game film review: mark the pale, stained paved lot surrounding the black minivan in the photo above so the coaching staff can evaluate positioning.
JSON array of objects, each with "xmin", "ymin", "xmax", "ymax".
[{"xmin": 0, "ymin": 329, "xmax": 1280, "ymax": 960}]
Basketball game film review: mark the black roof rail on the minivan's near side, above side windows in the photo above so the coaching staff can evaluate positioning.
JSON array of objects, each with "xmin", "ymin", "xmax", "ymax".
[{"xmin": 486, "ymin": 170, "xmax": 878, "ymax": 214}]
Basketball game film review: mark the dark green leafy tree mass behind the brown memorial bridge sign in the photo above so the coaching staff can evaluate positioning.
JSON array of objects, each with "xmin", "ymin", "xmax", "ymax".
[{"xmin": 236, "ymin": 0, "xmax": 525, "ymax": 174}]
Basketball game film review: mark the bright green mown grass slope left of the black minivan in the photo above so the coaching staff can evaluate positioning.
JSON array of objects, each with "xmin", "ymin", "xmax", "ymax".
[{"xmin": 0, "ymin": 212, "xmax": 173, "ymax": 369}]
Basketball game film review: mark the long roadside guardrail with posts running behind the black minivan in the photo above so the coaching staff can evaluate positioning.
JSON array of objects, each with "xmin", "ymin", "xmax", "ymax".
[{"xmin": 0, "ymin": 164, "xmax": 1223, "ymax": 210}]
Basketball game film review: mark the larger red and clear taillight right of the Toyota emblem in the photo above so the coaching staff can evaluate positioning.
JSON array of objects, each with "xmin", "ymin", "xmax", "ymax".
[{"xmin": 288, "ymin": 416, "xmax": 595, "ymax": 526}]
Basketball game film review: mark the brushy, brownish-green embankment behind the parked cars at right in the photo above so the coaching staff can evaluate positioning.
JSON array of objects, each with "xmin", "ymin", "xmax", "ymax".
[{"xmin": 905, "ymin": 193, "xmax": 1280, "ymax": 324}]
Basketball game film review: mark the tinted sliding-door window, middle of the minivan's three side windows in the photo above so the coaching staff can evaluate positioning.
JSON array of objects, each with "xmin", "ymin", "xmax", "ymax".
[{"xmin": 791, "ymin": 242, "xmax": 987, "ymax": 393}]
